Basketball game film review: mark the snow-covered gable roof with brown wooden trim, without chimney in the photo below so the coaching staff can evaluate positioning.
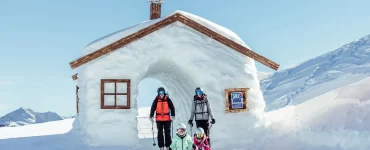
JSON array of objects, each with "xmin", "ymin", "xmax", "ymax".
[{"xmin": 70, "ymin": 10, "xmax": 280, "ymax": 70}]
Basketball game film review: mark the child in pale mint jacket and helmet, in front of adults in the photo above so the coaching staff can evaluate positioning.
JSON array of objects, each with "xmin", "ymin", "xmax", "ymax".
[{"xmin": 170, "ymin": 123, "xmax": 194, "ymax": 150}]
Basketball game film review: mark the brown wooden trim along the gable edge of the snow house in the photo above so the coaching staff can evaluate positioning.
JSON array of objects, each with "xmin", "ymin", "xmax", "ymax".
[{"xmin": 70, "ymin": 13, "xmax": 280, "ymax": 70}]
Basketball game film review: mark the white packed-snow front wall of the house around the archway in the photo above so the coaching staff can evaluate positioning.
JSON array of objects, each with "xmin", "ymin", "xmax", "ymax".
[{"xmin": 70, "ymin": 11, "xmax": 265, "ymax": 148}]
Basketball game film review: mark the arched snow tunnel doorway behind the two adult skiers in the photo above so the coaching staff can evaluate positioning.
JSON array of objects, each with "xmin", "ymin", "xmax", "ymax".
[{"xmin": 136, "ymin": 59, "xmax": 198, "ymax": 139}]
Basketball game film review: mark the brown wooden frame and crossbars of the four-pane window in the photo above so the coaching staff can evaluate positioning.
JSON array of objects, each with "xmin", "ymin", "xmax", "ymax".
[{"xmin": 100, "ymin": 79, "xmax": 131, "ymax": 109}]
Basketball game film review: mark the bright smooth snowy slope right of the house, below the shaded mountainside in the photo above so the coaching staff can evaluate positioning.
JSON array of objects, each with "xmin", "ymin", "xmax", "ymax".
[{"xmin": 265, "ymin": 78, "xmax": 370, "ymax": 150}]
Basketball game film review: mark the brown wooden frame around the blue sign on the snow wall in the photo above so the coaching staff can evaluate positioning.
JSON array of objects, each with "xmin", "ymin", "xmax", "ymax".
[{"xmin": 225, "ymin": 88, "xmax": 249, "ymax": 113}]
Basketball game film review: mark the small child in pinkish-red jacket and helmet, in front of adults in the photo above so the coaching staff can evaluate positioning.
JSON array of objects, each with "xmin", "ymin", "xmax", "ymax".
[{"xmin": 193, "ymin": 127, "xmax": 211, "ymax": 150}]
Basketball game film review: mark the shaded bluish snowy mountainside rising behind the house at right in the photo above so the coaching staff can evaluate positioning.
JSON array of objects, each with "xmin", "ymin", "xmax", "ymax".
[{"xmin": 260, "ymin": 35, "xmax": 370, "ymax": 111}]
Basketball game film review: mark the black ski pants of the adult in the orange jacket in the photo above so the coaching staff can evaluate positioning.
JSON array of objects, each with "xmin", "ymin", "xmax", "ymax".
[{"xmin": 157, "ymin": 121, "xmax": 172, "ymax": 148}]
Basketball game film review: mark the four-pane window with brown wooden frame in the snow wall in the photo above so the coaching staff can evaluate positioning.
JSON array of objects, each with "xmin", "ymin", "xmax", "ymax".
[{"xmin": 100, "ymin": 79, "xmax": 130, "ymax": 109}]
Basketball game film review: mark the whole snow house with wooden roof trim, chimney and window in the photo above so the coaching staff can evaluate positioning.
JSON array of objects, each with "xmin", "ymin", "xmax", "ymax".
[{"xmin": 70, "ymin": 2, "xmax": 279, "ymax": 148}]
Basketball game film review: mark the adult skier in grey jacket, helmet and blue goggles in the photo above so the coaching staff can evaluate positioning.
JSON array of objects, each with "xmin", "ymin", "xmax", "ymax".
[{"xmin": 188, "ymin": 87, "xmax": 216, "ymax": 143}]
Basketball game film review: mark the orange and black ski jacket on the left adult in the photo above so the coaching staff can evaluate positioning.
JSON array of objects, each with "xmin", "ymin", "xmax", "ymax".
[{"xmin": 150, "ymin": 95, "xmax": 175, "ymax": 121}]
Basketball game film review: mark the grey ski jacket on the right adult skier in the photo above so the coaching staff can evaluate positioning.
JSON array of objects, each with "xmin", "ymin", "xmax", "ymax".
[{"xmin": 189, "ymin": 94, "xmax": 214, "ymax": 120}]
